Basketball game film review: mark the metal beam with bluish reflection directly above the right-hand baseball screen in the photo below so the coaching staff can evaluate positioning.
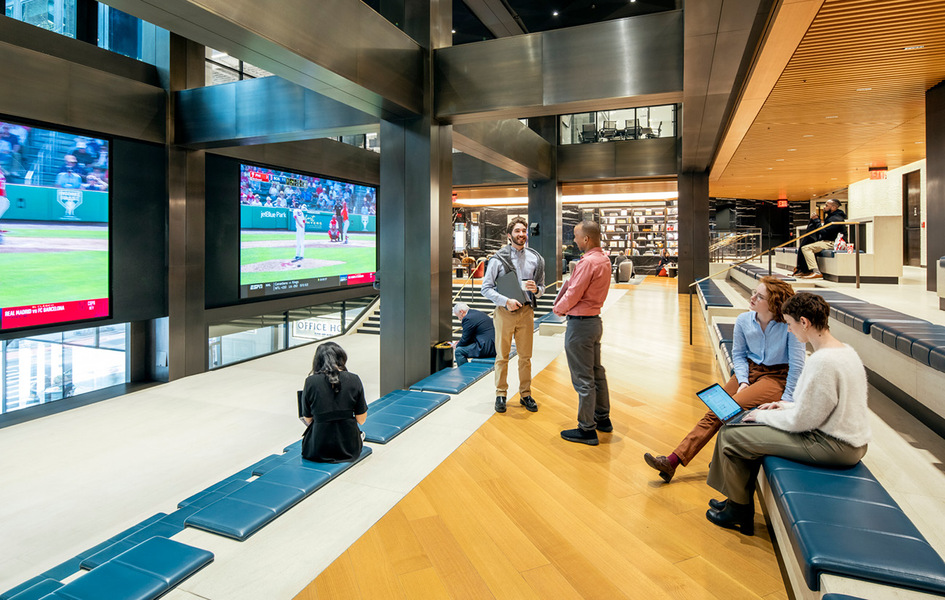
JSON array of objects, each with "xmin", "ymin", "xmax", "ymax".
[{"xmin": 174, "ymin": 77, "xmax": 380, "ymax": 148}]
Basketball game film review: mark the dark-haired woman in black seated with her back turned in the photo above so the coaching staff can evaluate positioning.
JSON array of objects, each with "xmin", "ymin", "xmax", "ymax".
[{"xmin": 302, "ymin": 342, "xmax": 367, "ymax": 463}]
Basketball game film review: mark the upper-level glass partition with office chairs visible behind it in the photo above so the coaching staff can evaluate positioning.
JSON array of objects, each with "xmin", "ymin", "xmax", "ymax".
[{"xmin": 560, "ymin": 104, "xmax": 677, "ymax": 144}]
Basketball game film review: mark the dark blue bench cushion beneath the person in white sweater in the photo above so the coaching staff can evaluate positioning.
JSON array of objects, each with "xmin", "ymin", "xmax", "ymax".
[{"xmin": 763, "ymin": 456, "xmax": 945, "ymax": 594}]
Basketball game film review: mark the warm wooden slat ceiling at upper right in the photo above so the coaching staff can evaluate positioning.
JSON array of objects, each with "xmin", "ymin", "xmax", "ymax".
[{"xmin": 709, "ymin": 0, "xmax": 945, "ymax": 200}]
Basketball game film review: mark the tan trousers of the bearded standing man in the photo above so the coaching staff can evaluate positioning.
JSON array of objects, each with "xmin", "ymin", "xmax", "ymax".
[{"xmin": 493, "ymin": 304, "xmax": 535, "ymax": 396}]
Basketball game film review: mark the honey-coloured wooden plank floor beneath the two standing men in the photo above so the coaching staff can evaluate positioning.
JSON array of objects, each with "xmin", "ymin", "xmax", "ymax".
[{"xmin": 297, "ymin": 278, "xmax": 787, "ymax": 600}]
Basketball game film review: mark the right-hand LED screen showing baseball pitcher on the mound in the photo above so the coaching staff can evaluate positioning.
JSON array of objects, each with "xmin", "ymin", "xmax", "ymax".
[{"xmin": 240, "ymin": 164, "xmax": 377, "ymax": 299}]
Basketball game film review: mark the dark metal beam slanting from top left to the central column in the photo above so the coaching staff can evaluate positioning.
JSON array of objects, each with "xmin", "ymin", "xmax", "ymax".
[{"xmin": 99, "ymin": 0, "xmax": 423, "ymax": 118}]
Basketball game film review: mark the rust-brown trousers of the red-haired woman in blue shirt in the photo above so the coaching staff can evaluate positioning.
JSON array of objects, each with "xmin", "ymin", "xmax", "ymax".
[{"xmin": 673, "ymin": 360, "xmax": 788, "ymax": 466}]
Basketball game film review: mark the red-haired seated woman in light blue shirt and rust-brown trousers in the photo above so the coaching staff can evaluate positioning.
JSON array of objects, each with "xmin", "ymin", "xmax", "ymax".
[{"xmin": 643, "ymin": 277, "xmax": 805, "ymax": 483}]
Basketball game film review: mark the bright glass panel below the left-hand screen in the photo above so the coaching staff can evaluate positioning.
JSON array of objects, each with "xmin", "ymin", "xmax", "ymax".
[{"xmin": 0, "ymin": 324, "xmax": 128, "ymax": 414}]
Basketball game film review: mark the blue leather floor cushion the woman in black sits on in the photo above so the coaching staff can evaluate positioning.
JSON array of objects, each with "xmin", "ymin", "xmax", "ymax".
[{"xmin": 184, "ymin": 446, "xmax": 371, "ymax": 541}]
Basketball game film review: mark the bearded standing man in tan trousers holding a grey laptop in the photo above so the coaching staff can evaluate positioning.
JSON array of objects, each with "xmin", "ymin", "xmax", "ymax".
[{"xmin": 482, "ymin": 217, "xmax": 545, "ymax": 412}]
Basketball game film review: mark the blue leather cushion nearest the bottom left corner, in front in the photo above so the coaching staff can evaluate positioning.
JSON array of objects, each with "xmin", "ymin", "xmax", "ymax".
[{"xmin": 47, "ymin": 537, "xmax": 213, "ymax": 600}]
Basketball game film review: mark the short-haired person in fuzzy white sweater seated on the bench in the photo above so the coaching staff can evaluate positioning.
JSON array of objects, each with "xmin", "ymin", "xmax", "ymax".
[{"xmin": 706, "ymin": 293, "xmax": 870, "ymax": 535}]
